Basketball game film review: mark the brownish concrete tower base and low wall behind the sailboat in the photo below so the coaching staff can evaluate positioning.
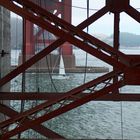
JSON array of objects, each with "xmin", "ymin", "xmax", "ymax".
[{"xmin": 17, "ymin": 54, "xmax": 109, "ymax": 73}]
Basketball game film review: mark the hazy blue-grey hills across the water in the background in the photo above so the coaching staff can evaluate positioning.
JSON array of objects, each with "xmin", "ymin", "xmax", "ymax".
[{"xmin": 11, "ymin": 17, "xmax": 140, "ymax": 49}]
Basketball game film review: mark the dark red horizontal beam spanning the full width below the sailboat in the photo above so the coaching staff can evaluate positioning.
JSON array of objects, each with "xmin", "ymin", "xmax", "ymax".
[{"xmin": 0, "ymin": 92, "xmax": 140, "ymax": 101}]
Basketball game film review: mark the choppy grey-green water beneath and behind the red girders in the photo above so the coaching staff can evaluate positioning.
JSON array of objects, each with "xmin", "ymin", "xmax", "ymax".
[{"xmin": 11, "ymin": 49, "xmax": 140, "ymax": 140}]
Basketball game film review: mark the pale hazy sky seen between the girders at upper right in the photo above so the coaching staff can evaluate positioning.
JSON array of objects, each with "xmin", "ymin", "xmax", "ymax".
[{"xmin": 72, "ymin": 0, "xmax": 140, "ymax": 35}]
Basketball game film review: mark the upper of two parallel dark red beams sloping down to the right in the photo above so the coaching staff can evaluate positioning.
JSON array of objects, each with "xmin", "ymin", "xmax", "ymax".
[{"xmin": 15, "ymin": 0, "xmax": 130, "ymax": 65}]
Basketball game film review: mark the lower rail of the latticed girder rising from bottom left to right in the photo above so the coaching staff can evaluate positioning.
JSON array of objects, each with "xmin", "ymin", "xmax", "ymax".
[{"xmin": 2, "ymin": 81, "xmax": 123, "ymax": 139}]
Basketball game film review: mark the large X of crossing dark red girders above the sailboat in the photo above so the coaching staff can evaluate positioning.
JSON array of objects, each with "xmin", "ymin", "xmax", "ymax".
[{"xmin": 0, "ymin": 0, "xmax": 131, "ymax": 86}]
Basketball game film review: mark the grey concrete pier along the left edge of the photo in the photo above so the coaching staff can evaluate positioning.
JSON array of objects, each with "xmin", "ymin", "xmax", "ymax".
[{"xmin": 0, "ymin": 7, "xmax": 11, "ymax": 121}]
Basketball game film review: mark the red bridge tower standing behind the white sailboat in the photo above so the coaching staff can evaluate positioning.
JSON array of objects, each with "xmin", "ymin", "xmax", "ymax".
[{"xmin": 22, "ymin": 0, "xmax": 75, "ymax": 69}]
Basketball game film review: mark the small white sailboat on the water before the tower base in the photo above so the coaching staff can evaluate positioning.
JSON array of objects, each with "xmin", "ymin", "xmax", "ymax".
[{"xmin": 52, "ymin": 54, "xmax": 69, "ymax": 79}]
